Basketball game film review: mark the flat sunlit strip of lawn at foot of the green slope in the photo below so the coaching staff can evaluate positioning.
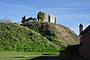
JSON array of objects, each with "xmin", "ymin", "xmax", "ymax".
[{"xmin": 0, "ymin": 52, "xmax": 59, "ymax": 60}]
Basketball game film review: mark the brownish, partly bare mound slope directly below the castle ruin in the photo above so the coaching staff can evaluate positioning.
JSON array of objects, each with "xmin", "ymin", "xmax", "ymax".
[{"xmin": 24, "ymin": 22, "xmax": 79, "ymax": 48}]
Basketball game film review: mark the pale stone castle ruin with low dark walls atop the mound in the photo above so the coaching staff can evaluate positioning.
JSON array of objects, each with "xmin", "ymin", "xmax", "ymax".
[{"xmin": 21, "ymin": 12, "xmax": 56, "ymax": 24}]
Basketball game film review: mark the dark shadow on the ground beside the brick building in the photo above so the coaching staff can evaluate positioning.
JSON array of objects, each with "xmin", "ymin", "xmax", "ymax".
[{"xmin": 31, "ymin": 45, "xmax": 86, "ymax": 60}]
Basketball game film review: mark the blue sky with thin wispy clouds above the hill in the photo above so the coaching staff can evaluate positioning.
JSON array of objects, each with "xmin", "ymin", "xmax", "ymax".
[{"xmin": 0, "ymin": 0, "xmax": 90, "ymax": 34}]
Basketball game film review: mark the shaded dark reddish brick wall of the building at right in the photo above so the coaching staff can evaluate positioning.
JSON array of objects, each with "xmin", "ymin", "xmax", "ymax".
[{"xmin": 79, "ymin": 30, "xmax": 90, "ymax": 60}]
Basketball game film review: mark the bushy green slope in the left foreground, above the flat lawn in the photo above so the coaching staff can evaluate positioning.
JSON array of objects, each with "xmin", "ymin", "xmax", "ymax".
[{"xmin": 0, "ymin": 23, "xmax": 59, "ymax": 52}]
